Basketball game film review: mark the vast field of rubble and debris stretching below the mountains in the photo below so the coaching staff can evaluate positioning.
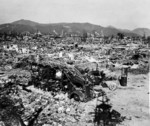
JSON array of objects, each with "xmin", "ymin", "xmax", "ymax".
[{"xmin": 0, "ymin": 33, "xmax": 150, "ymax": 126}]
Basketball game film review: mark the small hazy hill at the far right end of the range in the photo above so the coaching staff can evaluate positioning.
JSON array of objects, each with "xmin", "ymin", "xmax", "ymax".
[{"xmin": 132, "ymin": 28, "xmax": 150, "ymax": 36}]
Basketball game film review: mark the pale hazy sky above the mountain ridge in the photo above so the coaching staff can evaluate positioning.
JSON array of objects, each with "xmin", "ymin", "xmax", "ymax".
[{"xmin": 0, "ymin": 0, "xmax": 150, "ymax": 29}]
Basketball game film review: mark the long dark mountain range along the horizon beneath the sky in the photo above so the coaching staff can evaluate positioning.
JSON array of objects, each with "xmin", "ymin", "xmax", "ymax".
[{"xmin": 0, "ymin": 19, "xmax": 150, "ymax": 36}]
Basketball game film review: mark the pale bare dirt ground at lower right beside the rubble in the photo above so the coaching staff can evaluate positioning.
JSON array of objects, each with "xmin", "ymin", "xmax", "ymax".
[{"xmin": 82, "ymin": 74, "xmax": 150, "ymax": 126}]
